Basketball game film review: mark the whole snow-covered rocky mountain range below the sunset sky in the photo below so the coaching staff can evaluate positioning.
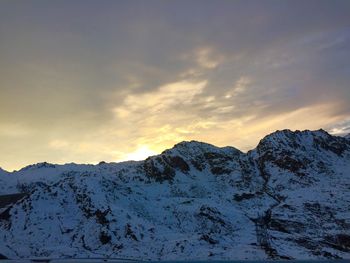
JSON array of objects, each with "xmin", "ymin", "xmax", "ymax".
[{"xmin": 0, "ymin": 130, "xmax": 350, "ymax": 260}]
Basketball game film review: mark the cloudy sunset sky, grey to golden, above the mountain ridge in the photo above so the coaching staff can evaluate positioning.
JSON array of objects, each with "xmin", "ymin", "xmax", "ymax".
[{"xmin": 0, "ymin": 0, "xmax": 350, "ymax": 170}]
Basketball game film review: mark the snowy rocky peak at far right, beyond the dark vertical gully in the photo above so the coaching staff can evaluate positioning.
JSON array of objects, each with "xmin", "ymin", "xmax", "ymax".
[{"xmin": 247, "ymin": 130, "xmax": 350, "ymax": 258}]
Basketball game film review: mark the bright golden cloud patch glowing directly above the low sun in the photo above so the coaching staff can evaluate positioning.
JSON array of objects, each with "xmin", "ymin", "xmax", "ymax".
[{"xmin": 113, "ymin": 80, "xmax": 208, "ymax": 151}]
